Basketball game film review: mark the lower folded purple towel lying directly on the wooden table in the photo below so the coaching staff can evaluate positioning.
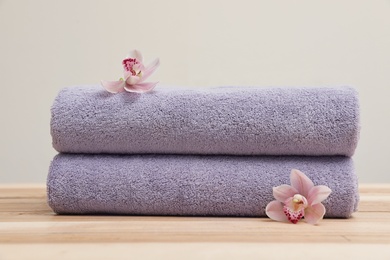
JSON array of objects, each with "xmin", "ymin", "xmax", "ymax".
[{"xmin": 47, "ymin": 154, "xmax": 359, "ymax": 218}]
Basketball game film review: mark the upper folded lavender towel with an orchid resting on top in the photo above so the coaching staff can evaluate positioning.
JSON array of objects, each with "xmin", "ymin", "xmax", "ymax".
[{"xmin": 51, "ymin": 86, "xmax": 360, "ymax": 156}]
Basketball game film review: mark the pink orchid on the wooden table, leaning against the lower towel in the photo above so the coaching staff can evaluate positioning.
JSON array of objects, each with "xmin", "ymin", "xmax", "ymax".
[{"xmin": 265, "ymin": 170, "xmax": 332, "ymax": 224}]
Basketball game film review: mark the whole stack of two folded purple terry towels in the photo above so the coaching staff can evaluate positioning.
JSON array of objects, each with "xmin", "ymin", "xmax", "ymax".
[{"xmin": 47, "ymin": 86, "xmax": 359, "ymax": 217}]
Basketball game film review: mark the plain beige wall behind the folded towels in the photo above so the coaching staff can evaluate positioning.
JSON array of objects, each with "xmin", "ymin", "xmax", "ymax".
[{"xmin": 0, "ymin": 0, "xmax": 390, "ymax": 183}]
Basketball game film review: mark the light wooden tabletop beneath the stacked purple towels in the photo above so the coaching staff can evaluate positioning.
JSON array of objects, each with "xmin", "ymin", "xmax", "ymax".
[{"xmin": 0, "ymin": 184, "xmax": 390, "ymax": 260}]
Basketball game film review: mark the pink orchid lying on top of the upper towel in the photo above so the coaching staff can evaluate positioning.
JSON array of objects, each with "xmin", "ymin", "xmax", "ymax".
[{"xmin": 101, "ymin": 50, "xmax": 160, "ymax": 93}]
